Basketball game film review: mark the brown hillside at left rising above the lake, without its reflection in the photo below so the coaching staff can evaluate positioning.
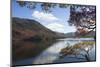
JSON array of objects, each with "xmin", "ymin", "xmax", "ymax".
[{"xmin": 12, "ymin": 18, "xmax": 66, "ymax": 39}]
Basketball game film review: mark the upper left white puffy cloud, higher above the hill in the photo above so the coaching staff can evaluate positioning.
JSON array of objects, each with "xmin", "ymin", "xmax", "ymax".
[{"xmin": 32, "ymin": 11, "xmax": 59, "ymax": 22}]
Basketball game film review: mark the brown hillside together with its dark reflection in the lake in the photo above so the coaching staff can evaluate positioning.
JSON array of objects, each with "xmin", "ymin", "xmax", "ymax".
[{"xmin": 12, "ymin": 17, "xmax": 64, "ymax": 59}]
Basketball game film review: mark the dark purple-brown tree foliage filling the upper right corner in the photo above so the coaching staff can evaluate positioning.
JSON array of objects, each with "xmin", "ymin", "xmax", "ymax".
[{"xmin": 69, "ymin": 5, "xmax": 96, "ymax": 35}]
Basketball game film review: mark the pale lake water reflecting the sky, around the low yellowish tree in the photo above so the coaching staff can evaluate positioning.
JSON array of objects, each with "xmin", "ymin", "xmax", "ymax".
[{"xmin": 16, "ymin": 38, "xmax": 95, "ymax": 65}]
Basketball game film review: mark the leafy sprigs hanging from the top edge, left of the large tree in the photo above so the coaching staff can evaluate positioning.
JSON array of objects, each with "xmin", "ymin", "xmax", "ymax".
[{"xmin": 17, "ymin": 1, "xmax": 57, "ymax": 12}]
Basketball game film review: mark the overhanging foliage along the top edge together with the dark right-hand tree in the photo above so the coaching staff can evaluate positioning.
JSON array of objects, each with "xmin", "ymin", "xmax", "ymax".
[{"xmin": 17, "ymin": 1, "xmax": 96, "ymax": 35}]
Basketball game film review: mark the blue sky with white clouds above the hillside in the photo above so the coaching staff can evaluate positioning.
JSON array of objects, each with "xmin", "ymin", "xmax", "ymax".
[{"xmin": 12, "ymin": 1, "xmax": 76, "ymax": 33}]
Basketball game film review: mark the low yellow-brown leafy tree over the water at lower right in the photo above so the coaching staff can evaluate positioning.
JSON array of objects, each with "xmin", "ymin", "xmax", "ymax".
[{"xmin": 60, "ymin": 42, "xmax": 95, "ymax": 61}]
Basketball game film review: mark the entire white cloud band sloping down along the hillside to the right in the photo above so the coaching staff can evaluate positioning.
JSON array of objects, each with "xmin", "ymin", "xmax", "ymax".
[{"xmin": 32, "ymin": 11, "xmax": 75, "ymax": 33}]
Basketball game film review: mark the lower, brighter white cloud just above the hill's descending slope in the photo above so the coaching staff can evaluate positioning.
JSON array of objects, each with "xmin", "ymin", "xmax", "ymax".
[{"xmin": 46, "ymin": 23, "xmax": 65, "ymax": 32}]
